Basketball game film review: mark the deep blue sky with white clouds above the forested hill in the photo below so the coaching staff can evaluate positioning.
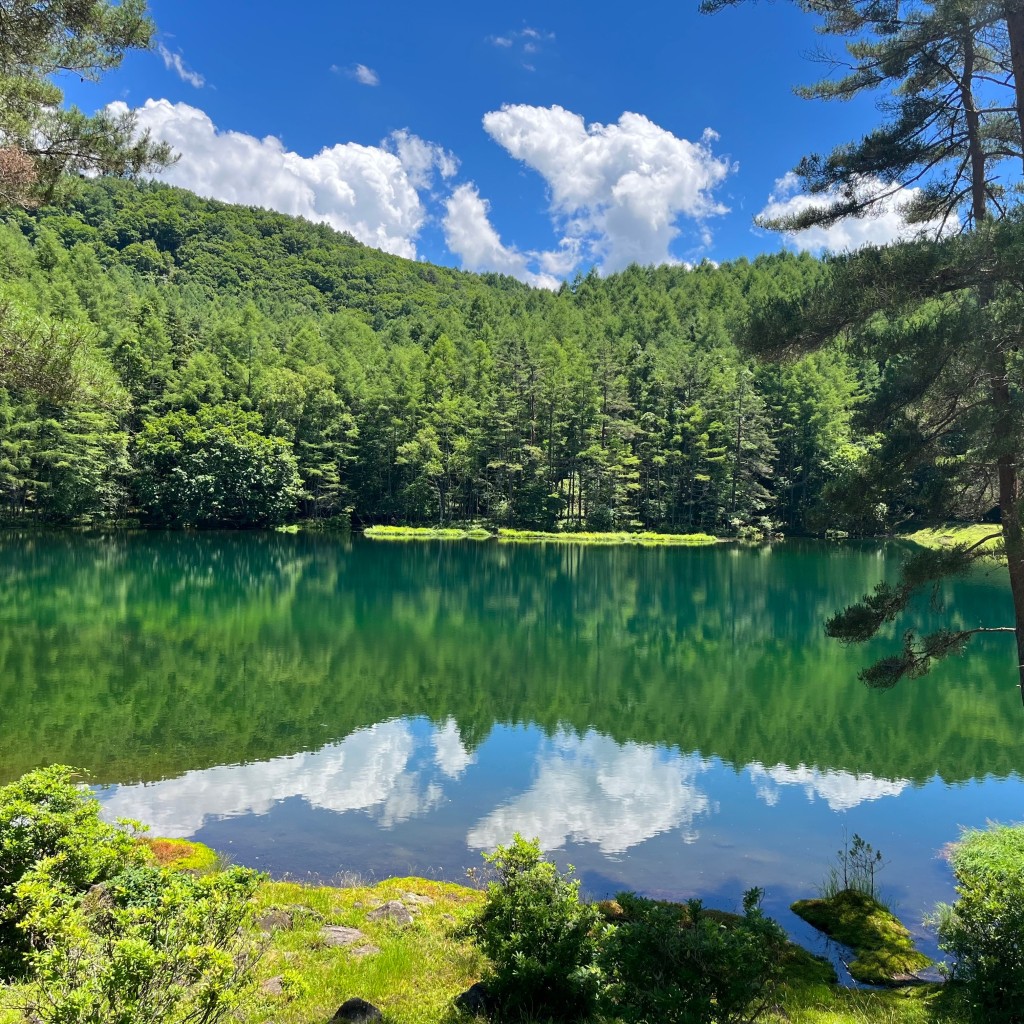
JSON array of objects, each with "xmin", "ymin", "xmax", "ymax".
[{"xmin": 59, "ymin": 0, "xmax": 933, "ymax": 286}]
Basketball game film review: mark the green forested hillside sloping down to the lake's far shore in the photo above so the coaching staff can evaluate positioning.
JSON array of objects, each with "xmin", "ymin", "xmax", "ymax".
[{"xmin": 0, "ymin": 180, "xmax": 872, "ymax": 532}]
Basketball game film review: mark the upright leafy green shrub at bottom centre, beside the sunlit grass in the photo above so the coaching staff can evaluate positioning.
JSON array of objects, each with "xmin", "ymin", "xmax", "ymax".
[{"xmin": 477, "ymin": 834, "xmax": 600, "ymax": 1020}]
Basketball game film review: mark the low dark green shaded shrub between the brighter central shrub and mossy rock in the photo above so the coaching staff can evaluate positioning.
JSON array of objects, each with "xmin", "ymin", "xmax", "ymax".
[{"xmin": 600, "ymin": 889, "xmax": 786, "ymax": 1024}]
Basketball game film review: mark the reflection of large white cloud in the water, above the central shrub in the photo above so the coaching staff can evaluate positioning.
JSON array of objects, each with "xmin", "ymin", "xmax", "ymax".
[{"xmin": 467, "ymin": 732, "xmax": 711, "ymax": 854}]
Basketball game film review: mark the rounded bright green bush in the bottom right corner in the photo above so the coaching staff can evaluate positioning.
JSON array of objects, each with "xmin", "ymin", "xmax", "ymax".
[{"xmin": 936, "ymin": 825, "xmax": 1024, "ymax": 1022}]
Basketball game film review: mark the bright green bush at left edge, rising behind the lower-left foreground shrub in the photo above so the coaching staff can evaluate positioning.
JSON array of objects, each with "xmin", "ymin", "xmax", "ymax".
[{"xmin": 0, "ymin": 765, "xmax": 143, "ymax": 974}]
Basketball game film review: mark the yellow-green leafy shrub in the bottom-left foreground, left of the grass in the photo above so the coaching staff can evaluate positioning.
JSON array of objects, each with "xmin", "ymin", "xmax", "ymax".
[{"xmin": 15, "ymin": 860, "xmax": 259, "ymax": 1024}]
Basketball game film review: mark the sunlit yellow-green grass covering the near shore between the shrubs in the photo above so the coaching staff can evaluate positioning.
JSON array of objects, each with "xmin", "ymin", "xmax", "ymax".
[{"xmin": 0, "ymin": 872, "xmax": 969, "ymax": 1024}]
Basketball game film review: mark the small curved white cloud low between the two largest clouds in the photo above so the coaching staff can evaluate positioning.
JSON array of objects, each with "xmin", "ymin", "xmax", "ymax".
[{"xmin": 442, "ymin": 183, "xmax": 575, "ymax": 289}]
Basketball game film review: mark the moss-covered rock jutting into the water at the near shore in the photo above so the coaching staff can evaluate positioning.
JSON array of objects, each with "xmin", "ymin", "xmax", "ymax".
[{"xmin": 791, "ymin": 889, "xmax": 934, "ymax": 985}]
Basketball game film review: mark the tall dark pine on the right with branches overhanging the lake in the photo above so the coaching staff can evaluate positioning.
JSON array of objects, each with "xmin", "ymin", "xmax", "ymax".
[{"xmin": 705, "ymin": 0, "xmax": 1024, "ymax": 699}]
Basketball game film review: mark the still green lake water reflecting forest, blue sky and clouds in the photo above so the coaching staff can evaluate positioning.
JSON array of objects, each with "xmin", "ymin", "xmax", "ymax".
[{"xmin": 0, "ymin": 532, "xmax": 1024, "ymax": 951}]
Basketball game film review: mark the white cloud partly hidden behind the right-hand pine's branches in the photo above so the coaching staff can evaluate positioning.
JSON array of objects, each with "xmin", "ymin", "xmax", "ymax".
[{"xmin": 758, "ymin": 171, "xmax": 943, "ymax": 253}]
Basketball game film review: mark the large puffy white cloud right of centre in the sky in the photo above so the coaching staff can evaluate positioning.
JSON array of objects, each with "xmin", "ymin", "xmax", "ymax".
[{"xmin": 483, "ymin": 104, "xmax": 733, "ymax": 272}]
